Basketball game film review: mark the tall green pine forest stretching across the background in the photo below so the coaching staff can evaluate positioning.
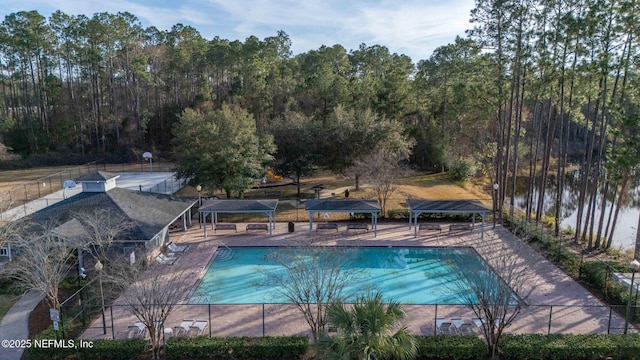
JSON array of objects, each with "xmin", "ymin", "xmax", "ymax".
[{"xmin": 0, "ymin": 0, "xmax": 640, "ymax": 253}]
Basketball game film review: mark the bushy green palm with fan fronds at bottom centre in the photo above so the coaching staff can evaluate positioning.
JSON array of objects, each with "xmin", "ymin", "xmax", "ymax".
[{"xmin": 318, "ymin": 292, "xmax": 417, "ymax": 360}]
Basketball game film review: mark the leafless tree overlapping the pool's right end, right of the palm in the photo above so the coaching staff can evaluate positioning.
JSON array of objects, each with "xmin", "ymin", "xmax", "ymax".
[{"xmin": 455, "ymin": 244, "xmax": 536, "ymax": 358}]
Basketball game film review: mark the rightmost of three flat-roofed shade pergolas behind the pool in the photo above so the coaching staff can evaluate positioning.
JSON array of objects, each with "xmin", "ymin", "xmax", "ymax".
[{"xmin": 407, "ymin": 199, "xmax": 491, "ymax": 240}]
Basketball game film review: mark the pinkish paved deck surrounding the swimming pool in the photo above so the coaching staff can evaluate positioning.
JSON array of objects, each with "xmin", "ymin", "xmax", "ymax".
[{"xmin": 82, "ymin": 222, "xmax": 637, "ymax": 339}]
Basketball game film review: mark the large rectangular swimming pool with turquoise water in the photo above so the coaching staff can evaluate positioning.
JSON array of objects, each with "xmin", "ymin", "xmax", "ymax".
[{"xmin": 188, "ymin": 247, "xmax": 502, "ymax": 304}]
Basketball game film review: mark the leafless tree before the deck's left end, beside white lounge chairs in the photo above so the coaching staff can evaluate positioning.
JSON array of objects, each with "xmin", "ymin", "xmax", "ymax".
[{"xmin": 120, "ymin": 265, "xmax": 187, "ymax": 359}]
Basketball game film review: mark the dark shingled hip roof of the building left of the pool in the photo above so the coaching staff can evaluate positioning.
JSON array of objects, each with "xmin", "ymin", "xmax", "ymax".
[{"xmin": 31, "ymin": 187, "xmax": 197, "ymax": 240}]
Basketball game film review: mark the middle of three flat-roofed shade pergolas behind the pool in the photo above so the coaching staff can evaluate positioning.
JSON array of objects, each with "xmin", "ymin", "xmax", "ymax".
[{"xmin": 305, "ymin": 199, "xmax": 380, "ymax": 237}]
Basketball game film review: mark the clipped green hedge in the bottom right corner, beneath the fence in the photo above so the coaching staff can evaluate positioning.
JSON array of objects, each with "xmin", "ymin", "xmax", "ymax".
[{"xmin": 500, "ymin": 334, "xmax": 640, "ymax": 360}]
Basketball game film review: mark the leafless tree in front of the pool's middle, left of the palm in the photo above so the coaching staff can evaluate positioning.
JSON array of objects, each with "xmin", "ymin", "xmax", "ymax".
[{"xmin": 265, "ymin": 240, "xmax": 360, "ymax": 341}]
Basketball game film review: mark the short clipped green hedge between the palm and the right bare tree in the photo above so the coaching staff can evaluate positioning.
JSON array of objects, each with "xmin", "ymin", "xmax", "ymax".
[{"xmin": 416, "ymin": 335, "xmax": 488, "ymax": 360}]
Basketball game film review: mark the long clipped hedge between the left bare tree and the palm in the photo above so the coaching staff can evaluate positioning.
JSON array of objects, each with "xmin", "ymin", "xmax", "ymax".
[{"xmin": 164, "ymin": 336, "xmax": 309, "ymax": 360}]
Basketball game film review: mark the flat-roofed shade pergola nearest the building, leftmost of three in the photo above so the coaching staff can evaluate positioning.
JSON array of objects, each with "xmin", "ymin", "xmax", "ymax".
[{"xmin": 198, "ymin": 199, "xmax": 278, "ymax": 239}]
